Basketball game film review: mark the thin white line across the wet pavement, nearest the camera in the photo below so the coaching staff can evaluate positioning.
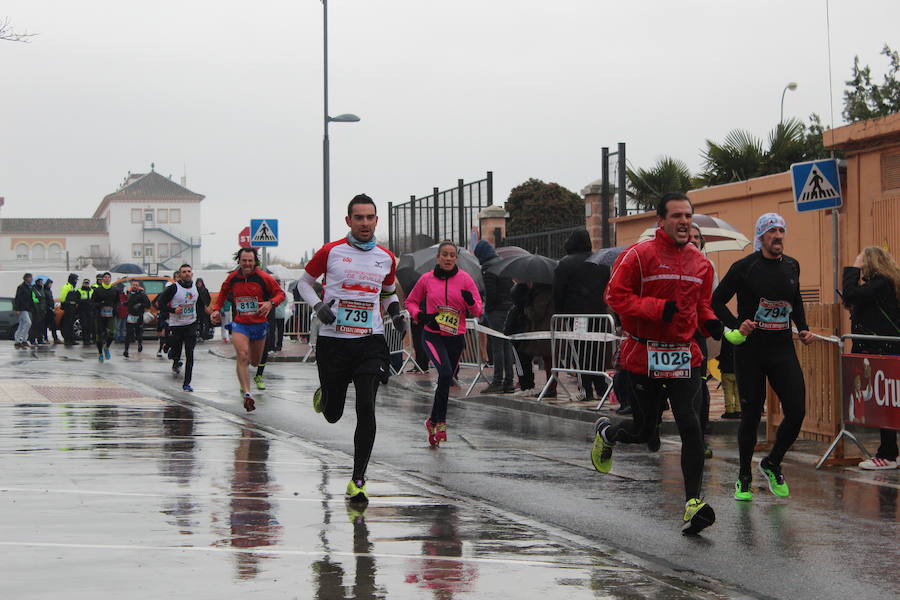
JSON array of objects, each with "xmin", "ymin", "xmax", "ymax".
[{"xmin": 0, "ymin": 541, "xmax": 641, "ymax": 573}]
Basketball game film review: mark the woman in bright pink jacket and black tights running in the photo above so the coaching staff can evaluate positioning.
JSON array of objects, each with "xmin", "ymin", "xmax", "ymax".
[{"xmin": 406, "ymin": 241, "xmax": 481, "ymax": 446}]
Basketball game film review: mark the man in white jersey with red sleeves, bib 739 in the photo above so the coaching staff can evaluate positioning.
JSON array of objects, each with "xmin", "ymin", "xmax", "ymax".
[{"xmin": 297, "ymin": 194, "xmax": 405, "ymax": 502}]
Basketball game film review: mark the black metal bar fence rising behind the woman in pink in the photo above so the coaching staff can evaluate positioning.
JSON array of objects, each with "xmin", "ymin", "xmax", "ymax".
[{"xmin": 388, "ymin": 171, "xmax": 494, "ymax": 256}]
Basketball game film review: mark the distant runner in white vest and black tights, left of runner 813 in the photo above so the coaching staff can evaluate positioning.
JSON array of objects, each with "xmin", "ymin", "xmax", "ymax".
[{"xmin": 157, "ymin": 264, "xmax": 210, "ymax": 392}]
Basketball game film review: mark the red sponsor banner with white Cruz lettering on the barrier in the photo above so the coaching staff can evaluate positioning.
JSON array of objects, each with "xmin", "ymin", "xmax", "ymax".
[{"xmin": 841, "ymin": 354, "xmax": 900, "ymax": 430}]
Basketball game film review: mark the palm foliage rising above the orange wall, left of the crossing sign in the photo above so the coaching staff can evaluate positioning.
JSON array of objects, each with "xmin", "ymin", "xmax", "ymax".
[{"xmin": 700, "ymin": 119, "xmax": 818, "ymax": 185}]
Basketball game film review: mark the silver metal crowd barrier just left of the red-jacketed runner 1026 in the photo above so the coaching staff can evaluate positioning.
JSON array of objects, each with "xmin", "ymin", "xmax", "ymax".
[{"xmin": 537, "ymin": 315, "xmax": 619, "ymax": 410}]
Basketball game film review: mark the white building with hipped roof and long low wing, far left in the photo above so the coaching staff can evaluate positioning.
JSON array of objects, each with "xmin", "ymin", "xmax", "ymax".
[{"xmin": 0, "ymin": 169, "xmax": 204, "ymax": 274}]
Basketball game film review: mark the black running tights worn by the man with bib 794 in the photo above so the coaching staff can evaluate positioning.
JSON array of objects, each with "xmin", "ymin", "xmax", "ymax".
[{"xmin": 734, "ymin": 342, "xmax": 806, "ymax": 478}]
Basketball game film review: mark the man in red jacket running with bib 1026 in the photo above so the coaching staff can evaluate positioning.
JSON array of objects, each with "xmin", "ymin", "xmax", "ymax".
[{"xmin": 591, "ymin": 193, "xmax": 722, "ymax": 534}]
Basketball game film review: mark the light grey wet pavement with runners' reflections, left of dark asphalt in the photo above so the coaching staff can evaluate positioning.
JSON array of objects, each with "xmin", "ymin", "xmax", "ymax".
[{"xmin": 0, "ymin": 378, "xmax": 728, "ymax": 600}]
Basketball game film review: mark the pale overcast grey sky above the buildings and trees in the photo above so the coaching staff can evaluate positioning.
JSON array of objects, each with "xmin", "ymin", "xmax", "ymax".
[{"xmin": 0, "ymin": 0, "xmax": 900, "ymax": 260}]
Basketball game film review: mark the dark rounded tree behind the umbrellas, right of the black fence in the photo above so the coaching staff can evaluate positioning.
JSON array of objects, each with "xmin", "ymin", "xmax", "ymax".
[{"xmin": 506, "ymin": 178, "xmax": 584, "ymax": 235}]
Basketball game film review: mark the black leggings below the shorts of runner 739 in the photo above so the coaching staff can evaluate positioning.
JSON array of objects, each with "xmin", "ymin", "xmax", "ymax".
[{"xmin": 322, "ymin": 373, "xmax": 379, "ymax": 480}]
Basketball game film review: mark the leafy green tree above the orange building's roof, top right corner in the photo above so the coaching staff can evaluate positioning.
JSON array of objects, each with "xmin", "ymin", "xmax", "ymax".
[{"xmin": 841, "ymin": 44, "xmax": 900, "ymax": 123}]
